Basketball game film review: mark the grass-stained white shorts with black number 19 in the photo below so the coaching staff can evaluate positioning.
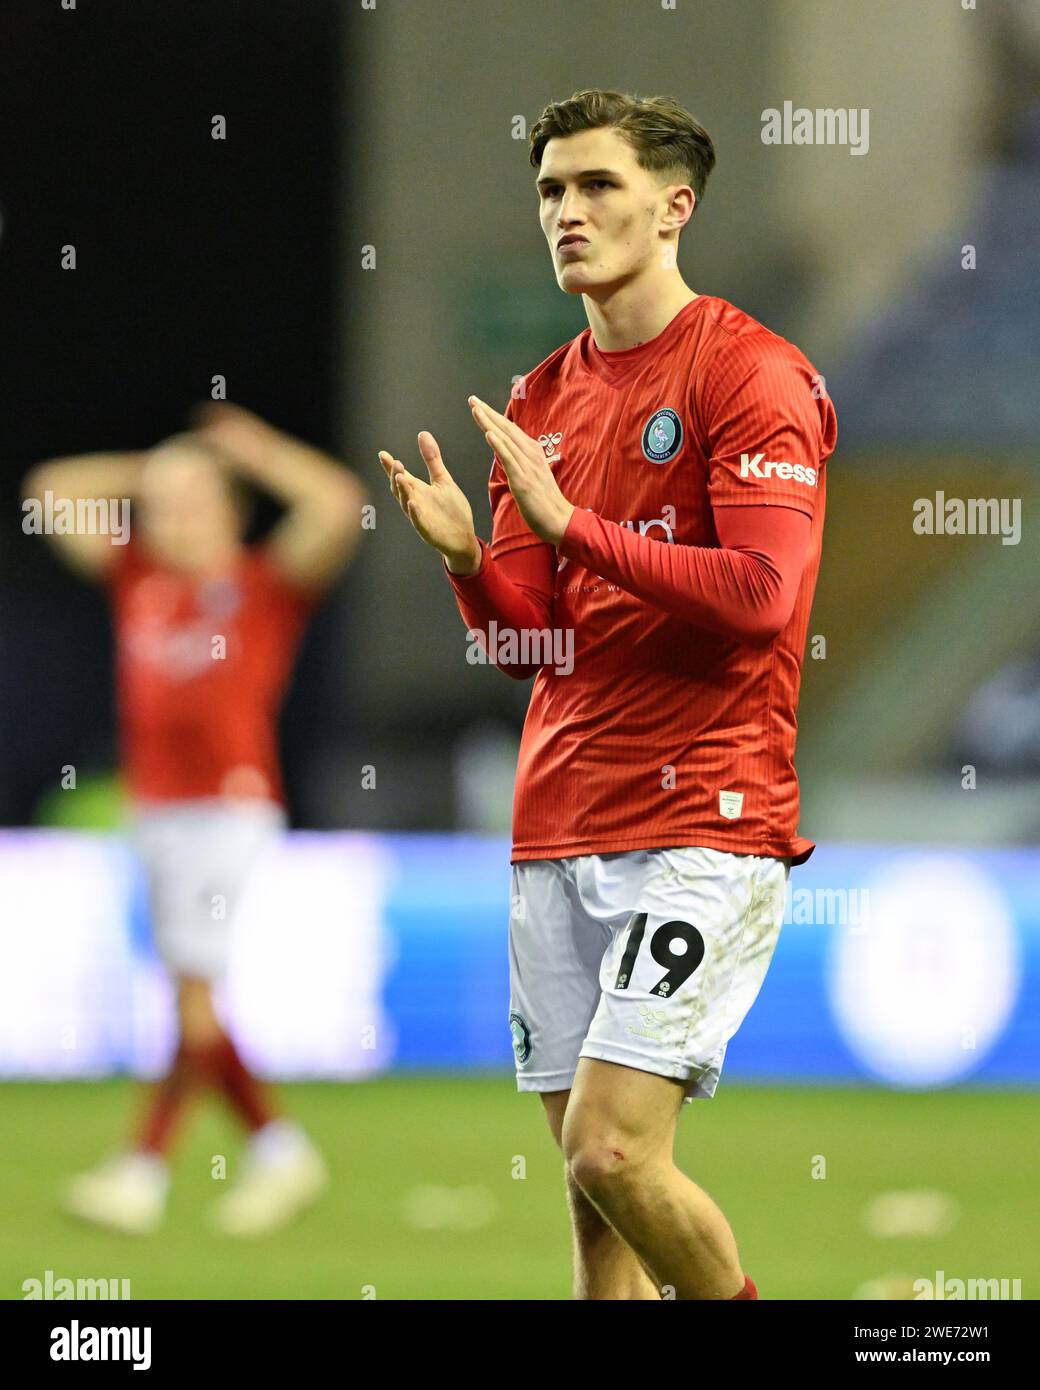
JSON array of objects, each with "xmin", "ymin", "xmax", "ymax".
[{"xmin": 509, "ymin": 847, "xmax": 791, "ymax": 1101}]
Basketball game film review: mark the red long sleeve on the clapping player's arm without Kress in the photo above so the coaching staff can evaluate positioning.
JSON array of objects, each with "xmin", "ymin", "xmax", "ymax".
[{"xmin": 444, "ymin": 538, "xmax": 556, "ymax": 681}]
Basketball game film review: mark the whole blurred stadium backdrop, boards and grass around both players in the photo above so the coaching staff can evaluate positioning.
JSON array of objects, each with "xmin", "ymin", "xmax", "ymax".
[{"xmin": 0, "ymin": 0, "xmax": 1040, "ymax": 1298}]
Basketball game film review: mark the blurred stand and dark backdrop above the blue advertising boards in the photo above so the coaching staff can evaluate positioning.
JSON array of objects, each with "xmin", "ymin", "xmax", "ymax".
[{"xmin": 0, "ymin": 0, "xmax": 1040, "ymax": 842}]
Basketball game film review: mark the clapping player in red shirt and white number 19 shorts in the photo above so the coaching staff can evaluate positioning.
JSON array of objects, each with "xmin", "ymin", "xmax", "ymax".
[{"xmin": 380, "ymin": 90, "xmax": 836, "ymax": 1300}]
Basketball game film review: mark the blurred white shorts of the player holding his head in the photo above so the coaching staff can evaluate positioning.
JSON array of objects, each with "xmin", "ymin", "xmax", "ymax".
[{"xmin": 132, "ymin": 798, "xmax": 285, "ymax": 983}]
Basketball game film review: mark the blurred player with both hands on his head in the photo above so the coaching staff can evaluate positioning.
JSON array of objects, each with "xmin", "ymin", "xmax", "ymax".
[{"xmin": 25, "ymin": 404, "xmax": 364, "ymax": 1236}]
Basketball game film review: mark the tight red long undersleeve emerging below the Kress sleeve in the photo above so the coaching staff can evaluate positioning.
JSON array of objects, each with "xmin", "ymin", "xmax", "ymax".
[{"xmin": 558, "ymin": 506, "xmax": 812, "ymax": 645}]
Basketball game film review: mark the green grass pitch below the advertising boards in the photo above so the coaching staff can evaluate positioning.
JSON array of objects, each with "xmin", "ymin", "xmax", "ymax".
[{"xmin": 0, "ymin": 1074, "xmax": 1040, "ymax": 1300}]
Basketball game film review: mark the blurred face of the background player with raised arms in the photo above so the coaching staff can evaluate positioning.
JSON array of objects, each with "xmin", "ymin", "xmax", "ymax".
[{"xmin": 136, "ymin": 445, "xmax": 239, "ymax": 571}]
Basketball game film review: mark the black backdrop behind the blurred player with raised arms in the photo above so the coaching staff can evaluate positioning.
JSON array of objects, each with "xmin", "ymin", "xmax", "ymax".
[{"xmin": 0, "ymin": 0, "xmax": 352, "ymax": 824}]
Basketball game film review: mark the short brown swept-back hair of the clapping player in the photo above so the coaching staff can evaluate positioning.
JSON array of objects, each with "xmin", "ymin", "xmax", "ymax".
[{"xmin": 530, "ymin": 89, "xmax": 715, "ymax": 207}]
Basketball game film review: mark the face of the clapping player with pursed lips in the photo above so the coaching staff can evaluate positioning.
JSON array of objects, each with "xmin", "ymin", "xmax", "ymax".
[{"xmin": 538, "ymin": 128, "xmax": 676, "ymax": 297}]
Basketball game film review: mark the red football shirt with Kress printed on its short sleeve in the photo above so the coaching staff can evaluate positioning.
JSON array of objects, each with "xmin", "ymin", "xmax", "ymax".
[{"xmin": 453, "ymin": 295, "xmax": 837, "ymax": 863}]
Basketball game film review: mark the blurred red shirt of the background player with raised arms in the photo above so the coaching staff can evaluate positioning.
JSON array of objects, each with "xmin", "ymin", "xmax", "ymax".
[{"xmin": 110, "ymin": 542, "xmax": 314, "ymax": 801}]
